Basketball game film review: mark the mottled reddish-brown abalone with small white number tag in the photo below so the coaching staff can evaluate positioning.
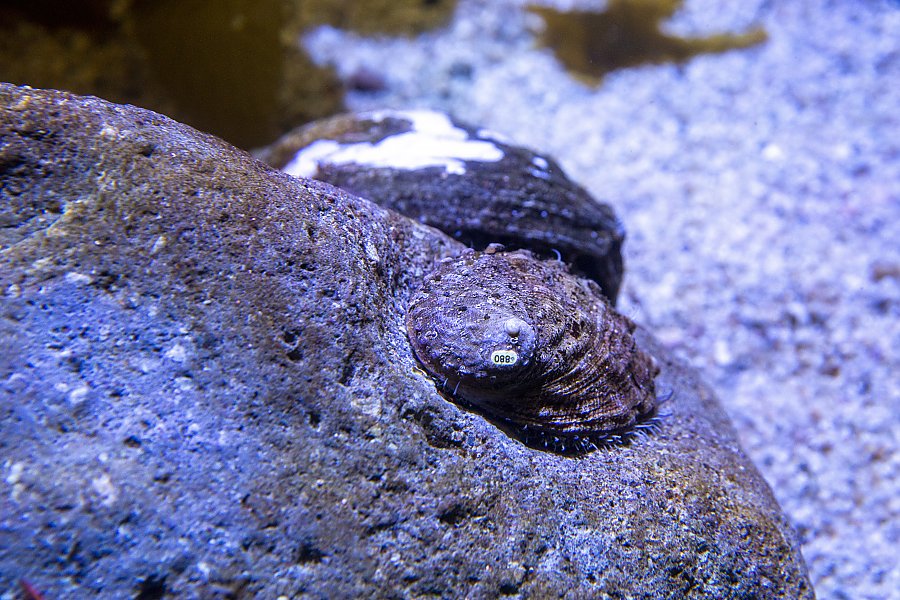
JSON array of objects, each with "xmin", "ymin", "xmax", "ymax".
[{"xmin": 407, "ymin": 251, "xmax": 658, "ymax": 451}]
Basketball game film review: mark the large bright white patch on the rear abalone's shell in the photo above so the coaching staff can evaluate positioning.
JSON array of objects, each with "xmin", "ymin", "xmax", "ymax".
[{"xmin": 282, "ymin": 110, "xmax": 504, "ymax": 177}]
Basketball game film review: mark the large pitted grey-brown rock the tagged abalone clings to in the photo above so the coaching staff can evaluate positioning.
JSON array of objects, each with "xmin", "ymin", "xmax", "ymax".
[{"xmin": 0, "ymin": 85, "xmax": 813, "ymax": 598}]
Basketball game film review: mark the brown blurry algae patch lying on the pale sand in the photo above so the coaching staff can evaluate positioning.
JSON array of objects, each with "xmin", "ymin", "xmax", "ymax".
[{"xmin": 528, "ymin": 0, "xmax": 768, "ymax": 83}]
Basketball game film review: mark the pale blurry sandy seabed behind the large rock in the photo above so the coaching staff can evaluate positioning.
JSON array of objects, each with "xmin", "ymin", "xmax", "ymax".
[{"xmin": 302, "ymin": 0, "xmax": 900, "ymax": 599}]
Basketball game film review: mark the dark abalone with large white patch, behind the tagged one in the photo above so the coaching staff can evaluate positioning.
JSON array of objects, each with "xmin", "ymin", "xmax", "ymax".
[{"xmin": 257, "ymin": 110, "xmax": 625, "ymax": 304}]
